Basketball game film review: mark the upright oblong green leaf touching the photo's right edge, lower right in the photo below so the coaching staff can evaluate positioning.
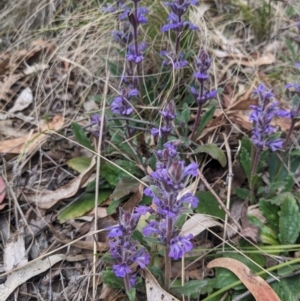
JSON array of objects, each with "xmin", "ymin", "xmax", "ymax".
[{"xmin": 278, "ymin": 194, "xmax": 300, "ymax": 245}]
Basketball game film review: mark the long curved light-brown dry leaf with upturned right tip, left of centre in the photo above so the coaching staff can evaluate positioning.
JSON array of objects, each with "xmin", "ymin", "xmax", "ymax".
[{"xmin": 24, "ymin": 157, "xmax": 96, "ymax": 209}]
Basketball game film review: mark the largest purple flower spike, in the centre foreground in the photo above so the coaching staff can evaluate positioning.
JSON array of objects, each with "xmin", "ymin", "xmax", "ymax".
[{"xmin": 139, "ymin": 141, "xmax": 199, "ymax": 259}]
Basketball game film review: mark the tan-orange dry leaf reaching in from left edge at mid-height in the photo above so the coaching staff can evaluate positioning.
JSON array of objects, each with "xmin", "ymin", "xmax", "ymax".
[{"xmin": 0, "ymin": 115, "xmax": 64, "ymax": 154}]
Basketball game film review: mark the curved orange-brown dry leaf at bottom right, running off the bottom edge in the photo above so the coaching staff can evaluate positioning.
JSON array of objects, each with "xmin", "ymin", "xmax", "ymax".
[{"xmin": 207, "ymin": 258, "xmax": 280, "ymax": 301}]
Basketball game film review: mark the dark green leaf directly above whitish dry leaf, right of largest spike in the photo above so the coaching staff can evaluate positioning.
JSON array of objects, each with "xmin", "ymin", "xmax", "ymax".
[{"xmin": 195, "ymin": 191, "xmax": 225, "ymax": 219}]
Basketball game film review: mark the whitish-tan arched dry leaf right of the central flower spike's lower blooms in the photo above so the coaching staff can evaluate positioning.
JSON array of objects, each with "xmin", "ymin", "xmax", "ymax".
[{"xmin": 180, "ymin": 213, "xmax": 223, "ymax": 236}]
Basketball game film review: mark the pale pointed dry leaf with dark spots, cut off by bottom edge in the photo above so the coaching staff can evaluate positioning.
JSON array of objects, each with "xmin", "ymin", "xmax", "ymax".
[{"xmin": 145, "ymin": 268, "xmax": 179, "ymax": 301}]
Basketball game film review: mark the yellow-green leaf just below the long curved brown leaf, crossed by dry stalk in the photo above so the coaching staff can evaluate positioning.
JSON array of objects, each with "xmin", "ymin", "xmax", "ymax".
[{"xmin": 58, "ymin": 191, "xmax": 111, "ymax": 223}]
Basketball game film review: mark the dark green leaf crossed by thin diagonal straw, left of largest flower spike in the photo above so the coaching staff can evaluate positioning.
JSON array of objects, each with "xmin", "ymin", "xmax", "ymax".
[{"xmin": 100, "ymin": 160, "xmax": 142, "ymax": 186}]
